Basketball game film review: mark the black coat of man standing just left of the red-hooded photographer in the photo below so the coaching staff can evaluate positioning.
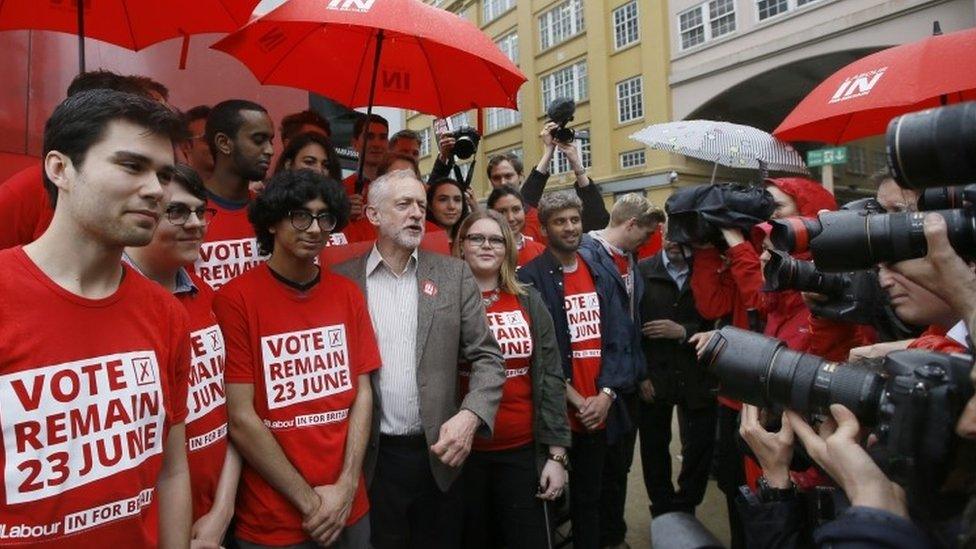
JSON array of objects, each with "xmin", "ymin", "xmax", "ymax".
[{"xmin": 638, "ymin": 250, "xmax": 717, "ymax": 409}]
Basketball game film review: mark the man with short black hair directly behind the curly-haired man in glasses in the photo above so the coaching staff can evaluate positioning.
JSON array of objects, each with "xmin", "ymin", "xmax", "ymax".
[{"xmin": 194, "ymin": 99, "xmax": 274, "ymax": 290}]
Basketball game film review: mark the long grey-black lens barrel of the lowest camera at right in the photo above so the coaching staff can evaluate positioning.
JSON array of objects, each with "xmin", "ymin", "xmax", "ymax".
[{"xmin": 699, "ymin": 326, "xmax": 885, "ymax": 426}]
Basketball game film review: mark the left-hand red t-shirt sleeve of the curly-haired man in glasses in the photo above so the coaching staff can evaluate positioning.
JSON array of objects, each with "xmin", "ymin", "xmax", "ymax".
[{"xmin": 213, "ymin": 284, "xmax": 254, "ymax": 383}]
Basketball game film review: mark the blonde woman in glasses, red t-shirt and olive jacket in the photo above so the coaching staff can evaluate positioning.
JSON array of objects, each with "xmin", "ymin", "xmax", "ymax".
[{"xmin": 454, "ymin": 211, "xmax": 571, "ymax": 548}]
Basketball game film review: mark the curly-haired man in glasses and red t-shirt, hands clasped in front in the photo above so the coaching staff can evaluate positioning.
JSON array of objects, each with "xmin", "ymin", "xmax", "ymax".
[{"xmin": 214, "ymin": 170, "xmax": 381, "ymax": 548}]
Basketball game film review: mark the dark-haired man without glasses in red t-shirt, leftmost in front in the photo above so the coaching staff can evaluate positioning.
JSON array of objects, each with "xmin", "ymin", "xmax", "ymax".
[{"xmin": 0, "ymin": 90, "xmax": 190, "ymax": 548}]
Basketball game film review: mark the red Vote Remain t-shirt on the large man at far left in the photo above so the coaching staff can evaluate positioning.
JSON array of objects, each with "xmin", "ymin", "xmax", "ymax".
[{"xmin": 0, "ymin": 247, "xmax": 189, "ymax": 549}]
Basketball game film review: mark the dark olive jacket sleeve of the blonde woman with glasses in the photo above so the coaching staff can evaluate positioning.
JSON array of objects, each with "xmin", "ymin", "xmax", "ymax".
[{"xmin": 518, "ymin": 287, "xmax": 573, "ymax": 472}]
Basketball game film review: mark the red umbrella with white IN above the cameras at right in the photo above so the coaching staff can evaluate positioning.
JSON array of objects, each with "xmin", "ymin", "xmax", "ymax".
[{"xmin": 773, "ymin": 29, "xmax": 976, "ymax": 143}]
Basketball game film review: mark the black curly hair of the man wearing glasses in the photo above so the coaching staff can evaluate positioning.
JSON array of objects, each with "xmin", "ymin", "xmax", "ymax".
[{"xmin": 247, "ymin": 170, "xmax": 349, "ymax": 255}]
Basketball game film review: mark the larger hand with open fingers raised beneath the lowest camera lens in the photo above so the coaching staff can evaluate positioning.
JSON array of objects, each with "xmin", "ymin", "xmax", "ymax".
[{"xmin": 784, "ymin": 404, "xmax": 908, "ymax": 518}]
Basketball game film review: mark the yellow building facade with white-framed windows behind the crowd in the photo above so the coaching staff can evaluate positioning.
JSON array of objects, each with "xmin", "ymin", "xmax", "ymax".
[{"xmin": 405, "ymin": 0, "xmax": 683, "ymax": 204}]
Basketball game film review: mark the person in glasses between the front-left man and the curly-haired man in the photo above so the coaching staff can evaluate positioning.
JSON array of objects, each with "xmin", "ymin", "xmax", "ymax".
[{"xmin": 123, "ymin": 164, "xmax": 241, "ymax": 546}]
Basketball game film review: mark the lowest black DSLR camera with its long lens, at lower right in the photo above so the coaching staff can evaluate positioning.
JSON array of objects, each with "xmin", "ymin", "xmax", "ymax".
[{"xmin": 701, "ymin": 326, "xmax": 973, "ymax": 520}]
